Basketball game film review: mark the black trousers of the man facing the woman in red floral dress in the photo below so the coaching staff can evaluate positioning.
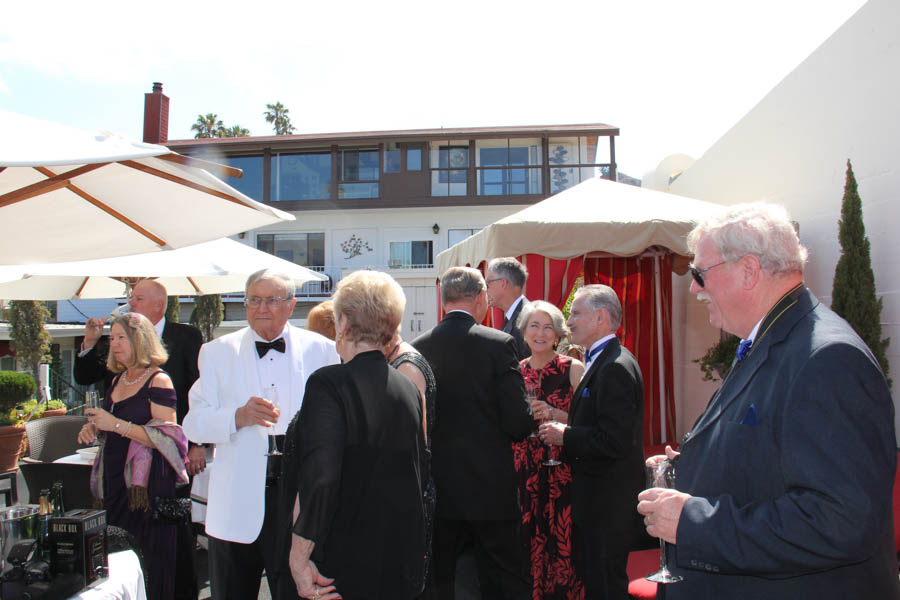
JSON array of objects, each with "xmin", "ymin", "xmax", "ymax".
[{"xmin": 572, "ymin": 523, "xmax": 629, "ymax": 600}]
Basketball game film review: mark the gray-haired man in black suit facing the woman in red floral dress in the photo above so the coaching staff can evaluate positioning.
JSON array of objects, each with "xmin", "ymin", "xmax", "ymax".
[{"xmin": 538, "ymin": 285, "xmax": 644, "ymax": 600}]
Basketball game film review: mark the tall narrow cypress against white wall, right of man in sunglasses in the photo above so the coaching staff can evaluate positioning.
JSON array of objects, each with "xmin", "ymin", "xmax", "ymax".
[{"xmin": 831, "ymin": 159, "xmax": 891, "ymax": 384}]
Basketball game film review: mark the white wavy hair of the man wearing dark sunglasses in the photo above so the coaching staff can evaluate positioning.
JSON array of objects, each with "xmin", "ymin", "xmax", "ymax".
[{"xmin": 687, "ymin": 202, "xmax": 808, "ymax": 275}]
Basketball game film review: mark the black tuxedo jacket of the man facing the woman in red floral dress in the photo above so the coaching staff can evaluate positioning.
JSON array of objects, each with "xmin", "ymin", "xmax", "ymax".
[{"xmin": 562, "ymin": 338, "xmax": 645, "ymax": 553}]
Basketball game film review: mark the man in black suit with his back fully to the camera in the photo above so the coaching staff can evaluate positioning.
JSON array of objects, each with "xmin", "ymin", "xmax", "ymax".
[{"xmin": 413, "ymin": 267, "xmax": 532, "ymax": 600}]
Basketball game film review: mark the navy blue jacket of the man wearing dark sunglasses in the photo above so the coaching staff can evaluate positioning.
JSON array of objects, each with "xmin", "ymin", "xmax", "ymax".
[{"xmin": 664, "ymin": 286, "xmax": 900, "ymax": 600}]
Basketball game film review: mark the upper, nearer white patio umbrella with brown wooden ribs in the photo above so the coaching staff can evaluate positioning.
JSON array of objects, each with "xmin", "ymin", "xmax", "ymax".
[{"xmin": 0, "ymin": 110, "xmax": 294, "ymax": 265}]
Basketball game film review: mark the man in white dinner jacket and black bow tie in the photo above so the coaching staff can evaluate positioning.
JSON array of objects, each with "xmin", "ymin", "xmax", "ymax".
[{"xmin": 183, "ymin": 270, "xmax": 339, "ymax": 600}]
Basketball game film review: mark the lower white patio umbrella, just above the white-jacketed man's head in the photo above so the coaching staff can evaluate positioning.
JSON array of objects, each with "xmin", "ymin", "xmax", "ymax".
[{"xmin": 0, "ymin": 238, "xmax": 328, "ymax": 300}]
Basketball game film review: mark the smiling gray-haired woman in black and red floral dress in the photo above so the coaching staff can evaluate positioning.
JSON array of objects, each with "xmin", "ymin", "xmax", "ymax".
[{"xmin": 513, "ymin": 300, "xmax": 584, "ymax": 600}]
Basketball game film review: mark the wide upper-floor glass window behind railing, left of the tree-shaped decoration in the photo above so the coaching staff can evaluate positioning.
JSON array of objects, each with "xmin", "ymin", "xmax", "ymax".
[{"xmin": 475, "ymin": 138, "xmax": 543, "ymax": 196}]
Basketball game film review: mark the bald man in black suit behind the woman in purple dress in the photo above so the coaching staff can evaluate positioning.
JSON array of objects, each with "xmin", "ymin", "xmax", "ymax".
[{"xmin": 74, "ymin": 279, "xmax": 206, "ymax": 600}]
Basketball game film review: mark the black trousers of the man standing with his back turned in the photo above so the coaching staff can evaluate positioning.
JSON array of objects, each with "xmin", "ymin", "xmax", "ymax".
[{"xmin": 429, "ymin": 519, "xmax": 532, "ymax": 600}]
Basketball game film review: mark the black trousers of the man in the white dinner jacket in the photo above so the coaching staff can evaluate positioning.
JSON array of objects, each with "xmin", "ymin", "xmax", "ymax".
[{"xmin": 209, "ymin": 457, "xmax": 289, "ymax": 600}]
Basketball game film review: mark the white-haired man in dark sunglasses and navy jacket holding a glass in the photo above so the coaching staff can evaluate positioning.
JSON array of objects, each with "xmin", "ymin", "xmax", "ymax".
[{"xmin": 638, "ymin": 204, "xmax": 900, "ymax": 600}]
